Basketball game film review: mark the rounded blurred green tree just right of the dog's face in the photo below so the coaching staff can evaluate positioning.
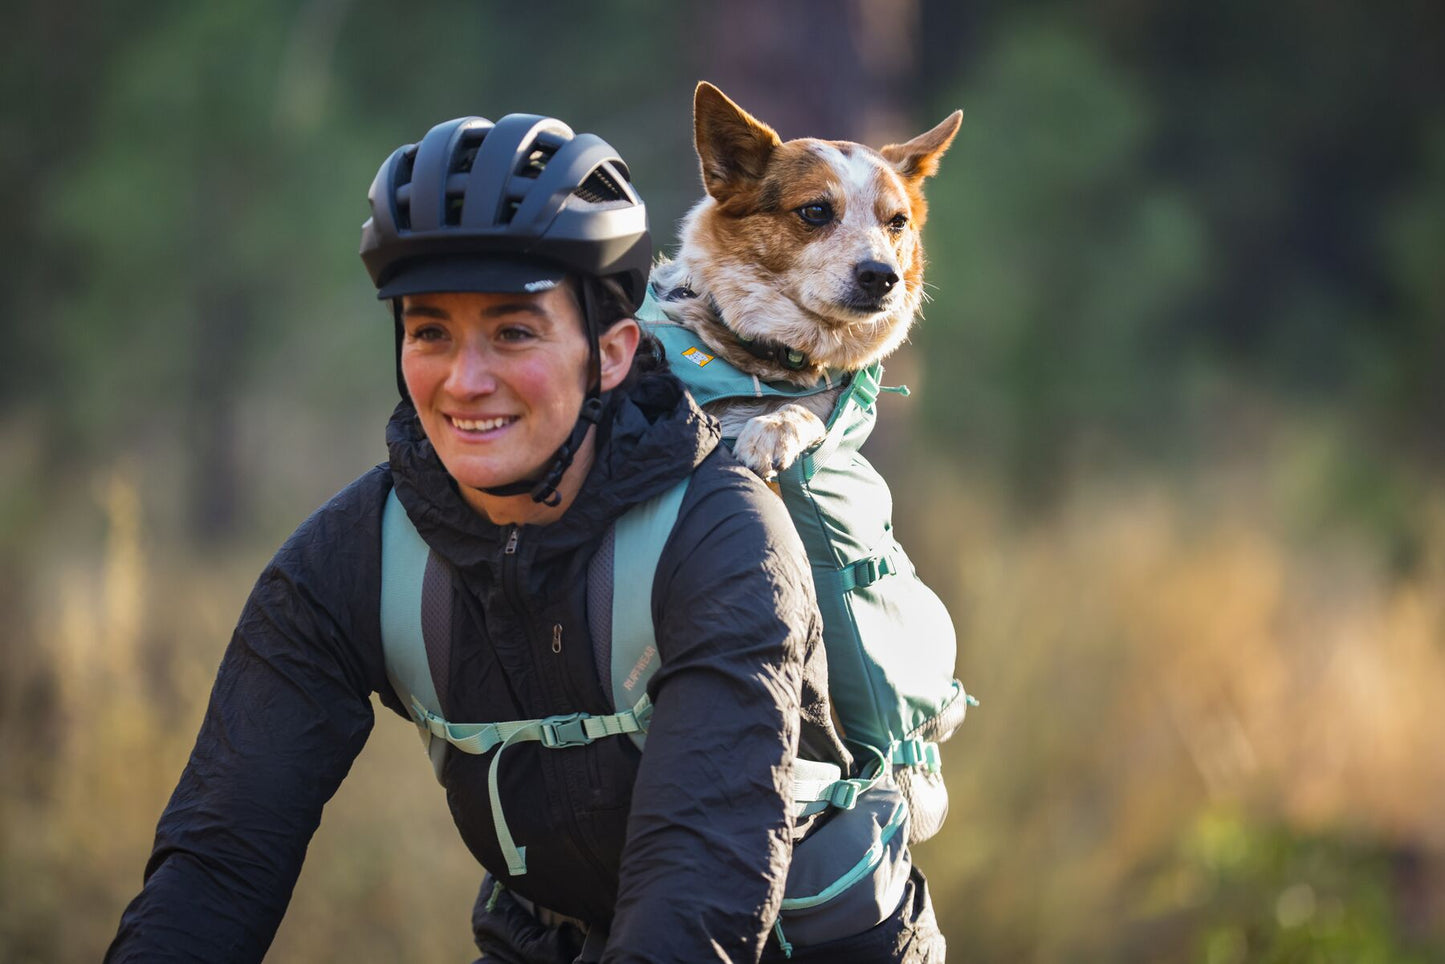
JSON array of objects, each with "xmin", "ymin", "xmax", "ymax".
[{"xmin": 918, "ymin": 17, "xmax": 1205, "ymax": 497}]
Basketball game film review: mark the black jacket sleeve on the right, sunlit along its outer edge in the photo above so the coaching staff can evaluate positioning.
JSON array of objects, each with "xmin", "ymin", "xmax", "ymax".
[{"xmin": 604, "ymin": 477, "xmax": 821, "ymax": 963}]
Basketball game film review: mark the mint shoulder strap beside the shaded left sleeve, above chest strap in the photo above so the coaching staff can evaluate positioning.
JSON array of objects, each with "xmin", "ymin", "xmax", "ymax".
[{"xmin": 381, "ymin": 490, "xmax": 449, "ymax": 780}]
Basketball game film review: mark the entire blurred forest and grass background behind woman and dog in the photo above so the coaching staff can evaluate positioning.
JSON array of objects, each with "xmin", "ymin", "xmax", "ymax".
[{"xmin": 0, "ymin": 0, "xmax": 1445, "ymax": 964}]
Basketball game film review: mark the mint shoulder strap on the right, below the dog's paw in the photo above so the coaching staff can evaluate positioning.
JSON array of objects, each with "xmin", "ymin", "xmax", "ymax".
[{"xmin": 588, "ymin": 475, "xmax": 692, "ymax": 749}]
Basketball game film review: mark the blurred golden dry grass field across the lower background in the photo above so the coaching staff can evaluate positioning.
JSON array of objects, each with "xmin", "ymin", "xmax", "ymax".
[{"xmin": 0, "ymin": 442, "xmax": 1445, "ymax": 964}]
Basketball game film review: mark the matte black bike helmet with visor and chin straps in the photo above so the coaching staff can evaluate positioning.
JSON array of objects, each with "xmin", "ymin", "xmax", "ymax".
[{"xmin": 361, "ymin": 114, "xmax": 652, "ymax": 504}]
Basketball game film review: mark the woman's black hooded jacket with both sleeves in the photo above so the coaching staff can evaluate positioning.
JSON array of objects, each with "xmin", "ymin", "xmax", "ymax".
[{"xmin": 107, "ymin": 374, "xmax": 867, "ymax": 961}]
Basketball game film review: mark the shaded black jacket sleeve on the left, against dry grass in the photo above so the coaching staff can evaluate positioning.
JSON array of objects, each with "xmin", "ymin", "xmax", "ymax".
[{"xmin": 105, "ymin": 486, "xmax": 380, "ymax": 963}]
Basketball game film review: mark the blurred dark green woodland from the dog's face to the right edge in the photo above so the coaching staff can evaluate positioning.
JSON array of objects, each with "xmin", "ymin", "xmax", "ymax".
[{"xmin": 918, "ymin": 3, "xmax": 1445, "ymax": 497}]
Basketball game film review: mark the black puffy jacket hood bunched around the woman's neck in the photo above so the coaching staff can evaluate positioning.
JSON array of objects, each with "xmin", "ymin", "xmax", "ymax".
[{"xmin": 386, "ymin": 365, "xmax": 721, "ymax": 568}]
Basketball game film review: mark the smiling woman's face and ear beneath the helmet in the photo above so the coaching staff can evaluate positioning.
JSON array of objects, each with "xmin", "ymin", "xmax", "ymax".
[{"xmin": 402, "ymin": 286, "xmax": 637, "ymax": 512}]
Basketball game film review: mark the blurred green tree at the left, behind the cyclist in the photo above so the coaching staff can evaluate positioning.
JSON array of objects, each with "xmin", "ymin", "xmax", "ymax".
[{"xmin": 43, "ymin": 0, "xmax": 343, "ymax": 539}]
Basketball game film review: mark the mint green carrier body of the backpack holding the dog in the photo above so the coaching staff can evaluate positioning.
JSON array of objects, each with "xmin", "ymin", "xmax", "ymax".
[{"xmin": 637, "ymin": 291, "xmax": 977, "ymax": 843}]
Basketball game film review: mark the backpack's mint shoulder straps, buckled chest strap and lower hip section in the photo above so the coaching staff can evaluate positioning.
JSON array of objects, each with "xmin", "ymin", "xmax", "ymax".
[{"xmin": 381, "ymin": 480, "xmax": 913, "ymax": 957}]
